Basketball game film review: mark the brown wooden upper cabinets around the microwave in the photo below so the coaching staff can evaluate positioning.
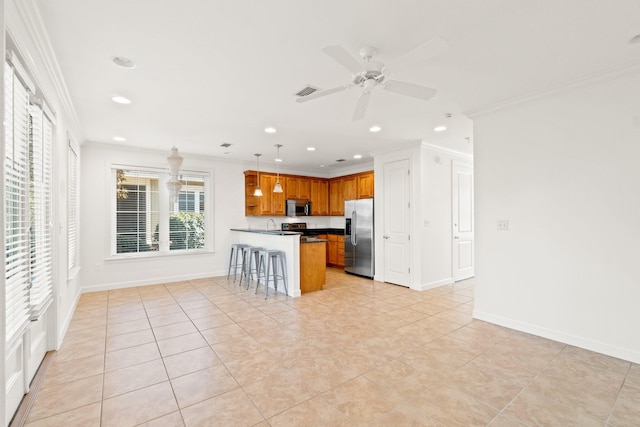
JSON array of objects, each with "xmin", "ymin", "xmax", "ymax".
[{"xmin": 244, "ymin": 171, "xmax": 374, "ymax": 216}]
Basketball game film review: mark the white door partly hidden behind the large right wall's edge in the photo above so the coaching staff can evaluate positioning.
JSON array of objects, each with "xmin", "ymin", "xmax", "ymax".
[{"xmin": 452, "ymin": 163, "xmax": 475, "ymax": 281}]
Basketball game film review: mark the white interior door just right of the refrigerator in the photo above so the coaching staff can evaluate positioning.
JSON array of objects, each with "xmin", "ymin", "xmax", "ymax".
[{"xmin": 382, "ymin": 159, "xmax": 411, "ymax": 286}]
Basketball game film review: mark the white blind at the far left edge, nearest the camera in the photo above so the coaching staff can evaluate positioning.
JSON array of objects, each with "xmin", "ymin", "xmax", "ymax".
[{"xmin": 3, "ymin": 63, "xmax": 30, "ymax": 342}]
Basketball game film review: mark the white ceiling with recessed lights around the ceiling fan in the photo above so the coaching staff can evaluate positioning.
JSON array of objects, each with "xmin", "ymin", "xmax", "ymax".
[{"xmin": 35, "ymin": 0, "xmax": 640, "ymax": 173}]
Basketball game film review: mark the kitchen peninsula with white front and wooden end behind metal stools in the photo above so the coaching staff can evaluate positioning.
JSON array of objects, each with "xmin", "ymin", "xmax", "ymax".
[{"xmin": 231, "ymin": 228, "xmax": 326, "ymax": 297}]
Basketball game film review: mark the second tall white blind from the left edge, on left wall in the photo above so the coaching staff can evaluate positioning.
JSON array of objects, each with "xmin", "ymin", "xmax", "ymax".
[{"xmin": 29, "ymin": 105, "xmax": 53, "ymax": 310}]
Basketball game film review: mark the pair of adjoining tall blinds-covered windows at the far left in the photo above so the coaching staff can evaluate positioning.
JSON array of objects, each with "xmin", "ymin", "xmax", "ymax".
[{"xmin": 3, "ymin": 56, "xmax": 53, "ymax": 342}]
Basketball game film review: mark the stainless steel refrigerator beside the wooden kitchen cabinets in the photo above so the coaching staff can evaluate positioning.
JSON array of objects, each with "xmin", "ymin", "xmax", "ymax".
[{"xmin": 344, "ymin": 199, "xmax": 374, "ymax": 279}]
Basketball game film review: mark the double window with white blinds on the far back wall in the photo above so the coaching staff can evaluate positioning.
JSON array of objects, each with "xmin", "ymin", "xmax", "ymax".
[{"xmin": 112, "ymin": 166, "xmax": 208, "ymax": 255}]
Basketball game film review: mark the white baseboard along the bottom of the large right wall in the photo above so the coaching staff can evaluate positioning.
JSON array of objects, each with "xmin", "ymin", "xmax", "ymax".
[{"xmin": 473, "ymin": 310, "xmax": 640, "ymax": 363}]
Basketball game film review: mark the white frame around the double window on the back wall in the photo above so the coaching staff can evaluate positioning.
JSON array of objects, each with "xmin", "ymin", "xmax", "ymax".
[{"xmin": 107, "ymin": 163, "xmax": 214, "ymax": 260}]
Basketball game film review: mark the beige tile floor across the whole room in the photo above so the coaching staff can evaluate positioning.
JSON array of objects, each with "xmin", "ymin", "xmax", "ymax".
[{"xmin": 22, "ymin": 269, "xmax": 640, "ymax": 427}]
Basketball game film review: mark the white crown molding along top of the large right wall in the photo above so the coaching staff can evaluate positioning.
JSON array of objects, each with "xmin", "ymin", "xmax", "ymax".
[{"xmin": 464, "ymin": 61, "xmax": 640, "ymax": 120}]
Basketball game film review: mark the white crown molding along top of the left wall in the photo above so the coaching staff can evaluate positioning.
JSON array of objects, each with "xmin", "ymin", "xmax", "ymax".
[{"xmin": 8, "ymin": 0, "xmax": 86, "ymax": 143}]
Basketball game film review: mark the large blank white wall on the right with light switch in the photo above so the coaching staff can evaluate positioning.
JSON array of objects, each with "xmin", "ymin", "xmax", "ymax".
[{"xmin": 474, "ymin": 72, "xmax": 640, "ymax": 363}]
